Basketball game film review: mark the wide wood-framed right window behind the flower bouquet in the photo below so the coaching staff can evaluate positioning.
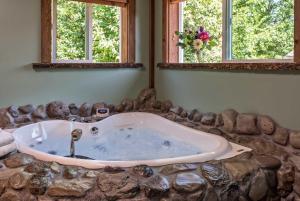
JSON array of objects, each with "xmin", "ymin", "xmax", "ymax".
[{"xmin": 163, "ymin": 0, "xmax": 299, "ymax": 63}]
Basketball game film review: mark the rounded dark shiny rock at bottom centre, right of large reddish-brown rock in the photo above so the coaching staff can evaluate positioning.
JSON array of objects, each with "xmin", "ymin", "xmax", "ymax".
[{"xmin": 142, "ymin": 175, "xmax": 170, "ymax": 198}]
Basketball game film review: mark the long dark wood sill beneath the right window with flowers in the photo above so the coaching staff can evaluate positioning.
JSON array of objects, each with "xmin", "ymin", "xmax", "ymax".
[{"xmin": 157, "ymin": 63, "xmax": 300, "ymax": 72}]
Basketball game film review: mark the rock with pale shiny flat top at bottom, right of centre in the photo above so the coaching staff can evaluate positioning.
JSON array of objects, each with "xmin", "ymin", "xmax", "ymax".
[{"xmin": 173, "ymin": 173, "xmax": 206, "ymax": 193}]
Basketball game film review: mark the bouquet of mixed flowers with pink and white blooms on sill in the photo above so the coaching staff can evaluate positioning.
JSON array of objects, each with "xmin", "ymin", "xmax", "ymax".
[{"xmin": 175, "ymin": 26, "xmax": 217, "ymax": 62}]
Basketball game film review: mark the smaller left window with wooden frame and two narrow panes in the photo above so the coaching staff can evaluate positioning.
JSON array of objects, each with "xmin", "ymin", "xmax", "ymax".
[{"xmin": 42, "ymin": 0, "xmax": 135, "ymax": 63}]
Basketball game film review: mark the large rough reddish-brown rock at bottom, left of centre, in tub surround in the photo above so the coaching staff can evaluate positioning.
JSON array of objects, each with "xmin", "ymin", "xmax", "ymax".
[{"xmin": 98, "ymin": 173, "xmax": 140, "ymax": 200}]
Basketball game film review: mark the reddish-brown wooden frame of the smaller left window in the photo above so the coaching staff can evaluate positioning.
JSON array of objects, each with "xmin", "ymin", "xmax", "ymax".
[{"xmin": 41, "ymin": 0, "xmax": 136, "ymax": 63}]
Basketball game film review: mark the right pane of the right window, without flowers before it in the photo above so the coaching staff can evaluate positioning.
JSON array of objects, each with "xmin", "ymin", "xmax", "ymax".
[{"xmin": 232, "ymin": 0, "xmax": 294, "ymax": 60}]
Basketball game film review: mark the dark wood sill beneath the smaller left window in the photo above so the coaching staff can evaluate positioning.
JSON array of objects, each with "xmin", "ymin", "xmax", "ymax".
[{"xmin": 32, "ymin": 63, "xmax": 144, "ymax": 71}]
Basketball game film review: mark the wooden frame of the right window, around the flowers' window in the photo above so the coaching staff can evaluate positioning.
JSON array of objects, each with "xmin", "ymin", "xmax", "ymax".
[{"xmin": 161, "ymin": 0, "xmax": 300, "ymax": 66}]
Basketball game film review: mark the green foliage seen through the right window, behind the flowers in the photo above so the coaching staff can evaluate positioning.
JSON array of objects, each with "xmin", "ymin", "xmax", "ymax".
[{"xmin": 184, "ymin": 0, "xmax": 294, "ymax": 62}]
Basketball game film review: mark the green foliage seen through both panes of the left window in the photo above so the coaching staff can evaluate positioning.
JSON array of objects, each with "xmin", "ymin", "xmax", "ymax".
[{"xmin": 56, "ymin": 0, "xmax": 120, "ymax": 62}]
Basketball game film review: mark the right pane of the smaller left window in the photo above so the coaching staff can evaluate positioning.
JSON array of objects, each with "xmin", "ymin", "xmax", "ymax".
[{"xmin": 93, "ymin": 5, "xmax": 121, "ymax": 62}]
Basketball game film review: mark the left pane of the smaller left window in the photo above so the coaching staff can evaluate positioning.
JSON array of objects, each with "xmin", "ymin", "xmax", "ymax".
[{"xmin": 56, "ymin": 0, "xmax": 86, "ymax": 60}]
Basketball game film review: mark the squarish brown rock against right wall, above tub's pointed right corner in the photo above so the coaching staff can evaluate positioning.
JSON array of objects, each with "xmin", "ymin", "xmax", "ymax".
[{"xmin": 236, "ymin": 114, "xmax": 259, "ymax": 135}]
